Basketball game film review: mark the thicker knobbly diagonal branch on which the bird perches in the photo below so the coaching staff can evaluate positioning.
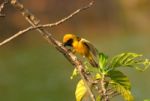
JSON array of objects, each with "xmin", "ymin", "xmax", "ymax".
[{"xmin": 11, "ymin": 0, "xmax": 95, "ymax": 101}]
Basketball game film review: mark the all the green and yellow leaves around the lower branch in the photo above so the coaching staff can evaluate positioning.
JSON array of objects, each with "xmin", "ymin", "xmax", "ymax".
[{"xmin": 72, "ymin": 53, "xmax": 150, "ymax": 101}]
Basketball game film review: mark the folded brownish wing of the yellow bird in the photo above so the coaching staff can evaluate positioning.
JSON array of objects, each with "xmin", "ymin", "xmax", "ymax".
[{"xmin": 81, "ymin": 38, "xmax": 98, "ymax": 58}]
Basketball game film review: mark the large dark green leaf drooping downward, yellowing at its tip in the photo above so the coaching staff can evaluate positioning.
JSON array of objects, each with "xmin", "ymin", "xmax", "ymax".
[{"xmin": 108, "ymin": 70, "xmax": 133, "ymax": 101}]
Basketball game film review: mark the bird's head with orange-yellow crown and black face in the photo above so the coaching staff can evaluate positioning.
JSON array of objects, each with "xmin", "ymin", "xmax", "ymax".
[{"xmin": 63, "ymin": 34, "xmax": 77, "ymax": 47}]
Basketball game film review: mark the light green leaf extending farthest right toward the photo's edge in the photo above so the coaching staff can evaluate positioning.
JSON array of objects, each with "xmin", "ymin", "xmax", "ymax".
[{"xmin": 109, "ymin": 53, "xmax": 150, "ymax": 71}]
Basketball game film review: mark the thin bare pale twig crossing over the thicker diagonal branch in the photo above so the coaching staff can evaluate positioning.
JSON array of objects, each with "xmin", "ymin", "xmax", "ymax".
[{"xmin": 0, "ymin": 1, "xmax": 94, "ymax": 46}]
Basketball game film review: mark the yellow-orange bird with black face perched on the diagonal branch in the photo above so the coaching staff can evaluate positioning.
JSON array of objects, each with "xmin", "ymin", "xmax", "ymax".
[{"xmin": 63, "ymin": 34, "xmax": 98, "ymax": 67}]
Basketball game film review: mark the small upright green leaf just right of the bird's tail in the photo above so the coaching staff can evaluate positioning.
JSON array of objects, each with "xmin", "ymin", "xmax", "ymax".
[{"xmin": 99, "ymin": 53, "xmax": 108, "ymax": 69}]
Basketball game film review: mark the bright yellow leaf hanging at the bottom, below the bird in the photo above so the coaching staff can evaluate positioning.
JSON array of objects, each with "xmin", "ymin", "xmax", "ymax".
[{"xmin": 75, "ymin": 80, "xmax": 87, "ymax": 101}]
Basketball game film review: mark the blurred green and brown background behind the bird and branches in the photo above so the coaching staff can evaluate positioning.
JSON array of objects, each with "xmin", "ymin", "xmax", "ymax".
[{"xmin": 0, "ymin": 0, "xmax": 150, "ymax": 101}]
